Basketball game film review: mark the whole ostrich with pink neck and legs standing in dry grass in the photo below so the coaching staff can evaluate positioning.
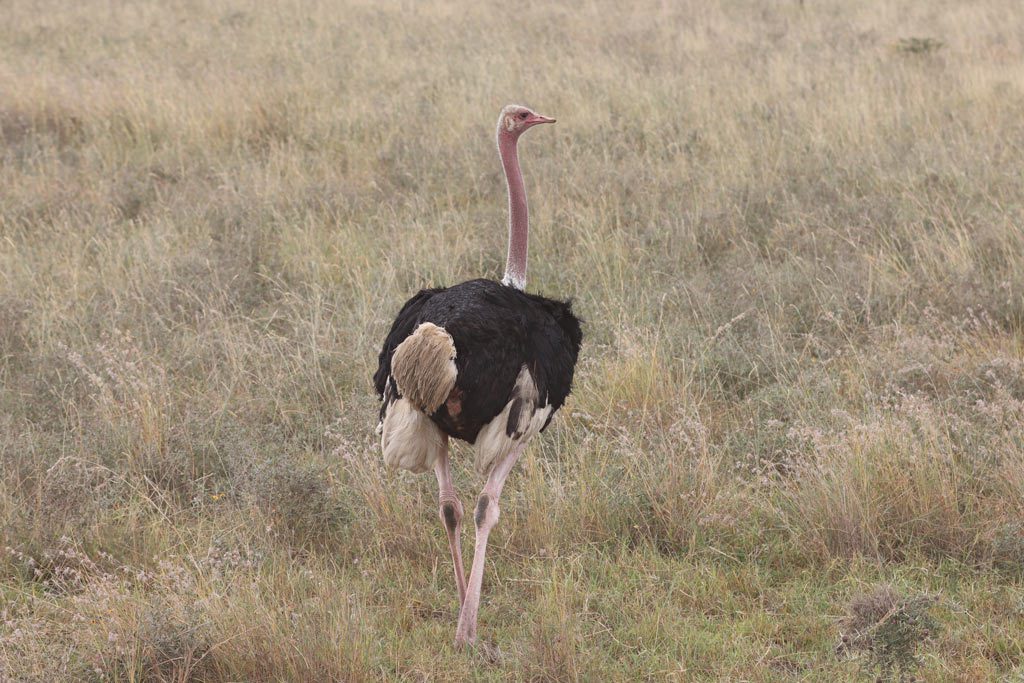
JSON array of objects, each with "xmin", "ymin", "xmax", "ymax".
[{"xmin": 374, "ymin": 104, "xmax": 583, "ymax": 646}]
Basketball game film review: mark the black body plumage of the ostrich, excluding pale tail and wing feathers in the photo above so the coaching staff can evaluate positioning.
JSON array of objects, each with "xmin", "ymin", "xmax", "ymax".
[{"xmin": 374, "ymin": 280, "xmax": 583, "ymax": 443}]
